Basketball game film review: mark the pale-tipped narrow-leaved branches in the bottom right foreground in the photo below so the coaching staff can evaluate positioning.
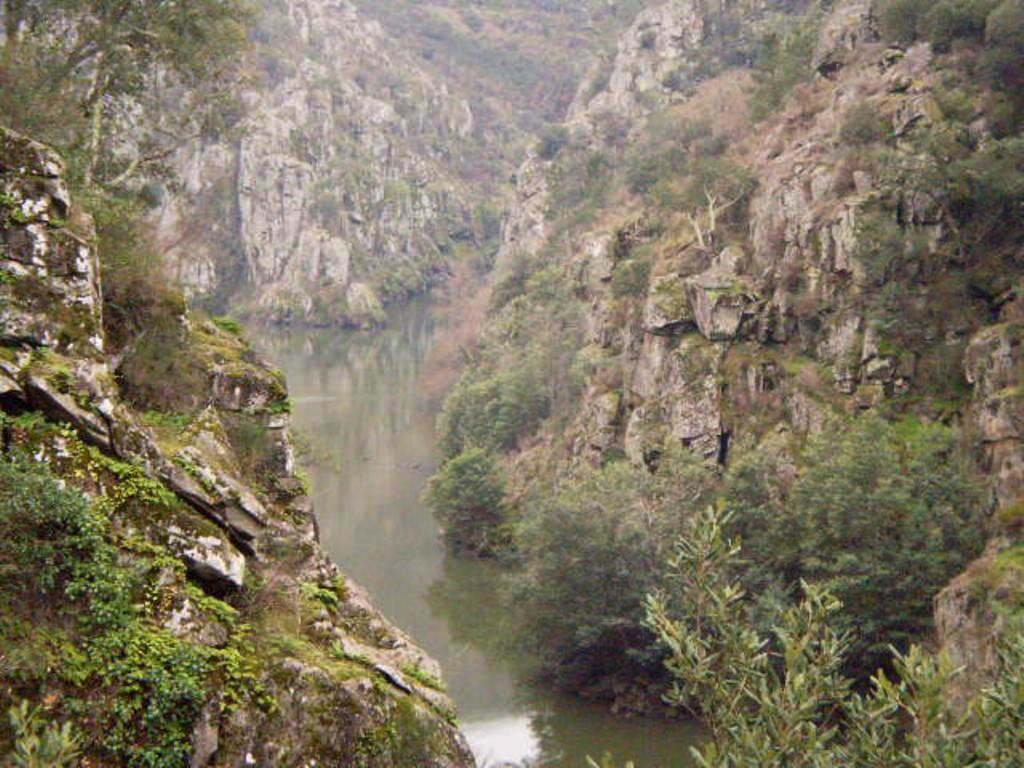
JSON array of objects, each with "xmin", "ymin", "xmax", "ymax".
[{"xmin": 647, "ymin": 509, "xmax": 1024, "ymax": 768}]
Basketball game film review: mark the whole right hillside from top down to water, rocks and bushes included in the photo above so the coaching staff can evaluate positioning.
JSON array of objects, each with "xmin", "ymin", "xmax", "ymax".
[{"xmin": 427, "ymin": 0, "xmax": 1024, "ymax": 749}]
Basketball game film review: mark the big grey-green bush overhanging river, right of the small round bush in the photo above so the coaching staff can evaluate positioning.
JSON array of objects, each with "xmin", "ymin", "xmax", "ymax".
[{"xmin": 512, "ymin": 451, "xmax": 712, "ymax": 689}]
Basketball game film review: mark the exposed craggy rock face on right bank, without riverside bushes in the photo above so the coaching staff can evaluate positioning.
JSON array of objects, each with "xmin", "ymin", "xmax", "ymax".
[{"xmin": 495, "ymin": 0, "xmax": 1024, "ymax": 687}]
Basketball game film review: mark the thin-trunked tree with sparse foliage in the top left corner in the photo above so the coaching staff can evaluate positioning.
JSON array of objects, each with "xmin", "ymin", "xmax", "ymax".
[{"xmin": 0, "ymin": 0, "xmax": 248, "ymax": 186}]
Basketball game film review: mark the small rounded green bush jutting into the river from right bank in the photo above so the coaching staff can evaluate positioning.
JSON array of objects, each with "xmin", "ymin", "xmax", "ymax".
[{"xmin": 425, "ymin": 446, "xmax": 505, "ymax": 554}]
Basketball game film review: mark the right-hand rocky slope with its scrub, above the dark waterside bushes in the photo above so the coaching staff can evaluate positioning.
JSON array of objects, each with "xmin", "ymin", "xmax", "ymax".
[{"xmin": 434, "ymin": 0, "xmax": 1024, "ymax": 708}]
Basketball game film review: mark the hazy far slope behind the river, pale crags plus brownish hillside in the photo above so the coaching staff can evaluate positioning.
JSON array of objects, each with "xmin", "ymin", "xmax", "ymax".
[{"xmin": 153, "ymin": 0, "xmax": 675, "ymax": 326}]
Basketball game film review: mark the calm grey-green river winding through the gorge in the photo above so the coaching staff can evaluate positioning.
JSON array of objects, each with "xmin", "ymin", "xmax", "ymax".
[{"xmin": 254, "ymin": 300, "xmax": 699, "ymax": 768}]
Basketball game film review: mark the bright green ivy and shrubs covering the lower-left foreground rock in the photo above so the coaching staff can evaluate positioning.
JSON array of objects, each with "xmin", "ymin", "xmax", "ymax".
[{"xmin": 0, "ymin": 456, "xmax": 226, "ymax": 768}]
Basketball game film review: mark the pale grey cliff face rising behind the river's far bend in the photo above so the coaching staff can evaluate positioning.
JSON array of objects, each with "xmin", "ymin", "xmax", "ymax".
[{"xmin": 159, "ymin": 0, "xmax": 479, "ymax": 325}]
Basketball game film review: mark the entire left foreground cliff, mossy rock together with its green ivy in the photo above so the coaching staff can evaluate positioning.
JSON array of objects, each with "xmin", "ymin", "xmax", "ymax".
[{"xmin": 0, "ymin": 132, "xmax": 474, "ymax": 767}]
